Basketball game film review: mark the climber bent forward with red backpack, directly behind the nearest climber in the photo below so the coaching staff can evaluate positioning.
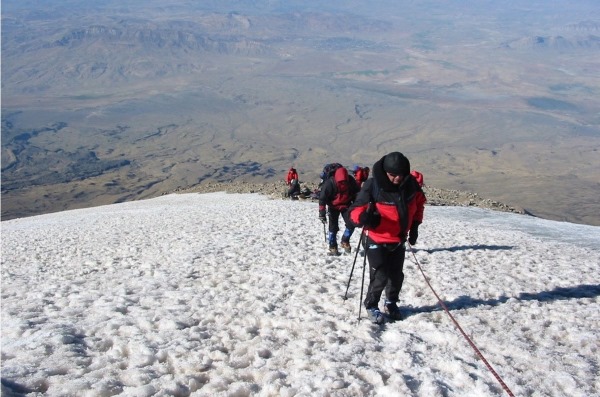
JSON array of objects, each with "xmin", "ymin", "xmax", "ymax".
[{"xmin": 319, "ymin": 167, "xmax": 359, "ymax": 255}]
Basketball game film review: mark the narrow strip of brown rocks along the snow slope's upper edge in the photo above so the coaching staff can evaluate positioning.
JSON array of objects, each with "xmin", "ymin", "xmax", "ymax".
[{"xmin": 171, "ymin": 181, "xmax": 527, "ymax": 215}]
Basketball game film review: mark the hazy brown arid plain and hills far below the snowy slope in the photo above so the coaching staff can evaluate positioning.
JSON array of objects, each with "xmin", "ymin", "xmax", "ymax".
[{"xmin": 2, "ymin": 0, "xmax": 600, "ymax": 226}]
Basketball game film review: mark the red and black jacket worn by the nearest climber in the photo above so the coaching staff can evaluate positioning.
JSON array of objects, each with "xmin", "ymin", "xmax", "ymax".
[{"xmin": 349, "ymin": 158, "xmax": 427, "ymax": 244}]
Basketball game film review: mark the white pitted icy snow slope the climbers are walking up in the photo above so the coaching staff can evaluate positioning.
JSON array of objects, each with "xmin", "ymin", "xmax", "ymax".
[{"xmin": 1, "ymin": 193, "xmax": 600, "ymax": 397}]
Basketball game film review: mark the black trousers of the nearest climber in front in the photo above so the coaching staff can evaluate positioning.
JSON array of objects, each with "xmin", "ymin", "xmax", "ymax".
[{"xmin": 364, "ymin": 239, "xmax": 406, "ymax": 309}]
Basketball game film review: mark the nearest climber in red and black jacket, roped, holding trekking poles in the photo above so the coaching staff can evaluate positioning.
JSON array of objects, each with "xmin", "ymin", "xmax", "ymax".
[{"xmin": 349, "ymin": 152, "xmax": 427, "ymax": 324}]
